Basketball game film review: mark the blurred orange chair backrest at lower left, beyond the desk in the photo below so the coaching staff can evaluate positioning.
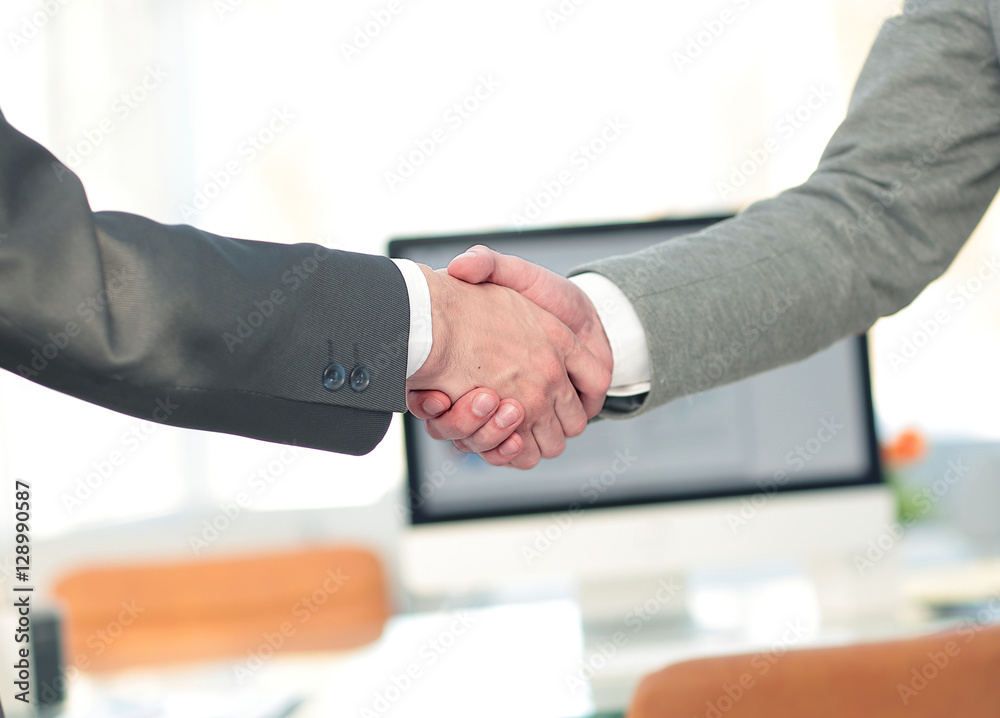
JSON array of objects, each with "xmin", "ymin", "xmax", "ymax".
[{"xmin": 54, "ymin": 547, "xmax": 390, "ymax": 670}]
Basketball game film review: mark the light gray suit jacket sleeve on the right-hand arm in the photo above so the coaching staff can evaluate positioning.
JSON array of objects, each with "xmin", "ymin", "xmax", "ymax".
[{"xmin": 576, "ymin": 0, "xmax": 1000, "ymax": 420}]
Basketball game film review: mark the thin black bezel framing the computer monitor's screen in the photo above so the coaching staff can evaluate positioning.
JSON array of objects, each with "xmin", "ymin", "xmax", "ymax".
[{"xmin": 389, "ymin": 215, "xmax": 885, "ymax": 526}]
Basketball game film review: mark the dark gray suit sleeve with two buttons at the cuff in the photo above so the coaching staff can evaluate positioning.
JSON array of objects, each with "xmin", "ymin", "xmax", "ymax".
[{"xmin": 0, "ymin": 108, "xmax": 409, "ymax": 454}]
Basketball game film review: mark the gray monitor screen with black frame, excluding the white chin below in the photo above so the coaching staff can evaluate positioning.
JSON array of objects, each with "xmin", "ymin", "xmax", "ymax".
[{"xmin": 389, "ymin": 217, "xmax": 881, "ymax": 524}]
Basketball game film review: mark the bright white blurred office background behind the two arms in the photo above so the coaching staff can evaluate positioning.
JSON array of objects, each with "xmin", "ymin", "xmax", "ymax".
[{"xmin": 0, "ymin": 0, "xmax": 1000, "ymax": 596}]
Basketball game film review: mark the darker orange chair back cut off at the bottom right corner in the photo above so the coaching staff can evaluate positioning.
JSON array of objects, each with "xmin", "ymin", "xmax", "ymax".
[{"xmin": 628, "ymin": 624, "xmax": 1000, "ymax": 718}]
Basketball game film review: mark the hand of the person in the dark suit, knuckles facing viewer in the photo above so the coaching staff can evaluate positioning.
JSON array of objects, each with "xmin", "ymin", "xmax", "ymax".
[{"xmin": 407, "ymin": 267, "xmax": 611, "ymax": 468}]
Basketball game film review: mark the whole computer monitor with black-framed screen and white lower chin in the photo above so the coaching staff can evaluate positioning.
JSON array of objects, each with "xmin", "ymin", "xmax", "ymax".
[{"xmin": 390, "ymin": 217, "xmax": 894, "ymax": 620}]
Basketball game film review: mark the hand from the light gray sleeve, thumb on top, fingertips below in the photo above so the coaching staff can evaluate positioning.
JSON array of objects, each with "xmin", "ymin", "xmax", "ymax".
[{"xmin": 407, "ymin": 250, "xmax": 613, "ymax": 465}]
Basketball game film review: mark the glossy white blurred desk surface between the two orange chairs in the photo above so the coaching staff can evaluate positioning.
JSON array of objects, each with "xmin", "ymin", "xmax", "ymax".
[{"xmin": 58, "ymin": 562, "xmax": 1000, "ymax": 718}]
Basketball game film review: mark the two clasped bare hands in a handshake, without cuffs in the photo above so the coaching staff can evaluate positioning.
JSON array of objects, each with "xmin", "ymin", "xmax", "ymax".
[{"xmin": 406, "ymin": 246, "xmax": 613, "ymax": 469}]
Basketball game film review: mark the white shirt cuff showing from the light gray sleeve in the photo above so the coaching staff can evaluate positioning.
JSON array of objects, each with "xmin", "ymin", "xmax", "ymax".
[{"xmin": 570, "ymin": 272, "xmax": 650, "ymax": 396}]
